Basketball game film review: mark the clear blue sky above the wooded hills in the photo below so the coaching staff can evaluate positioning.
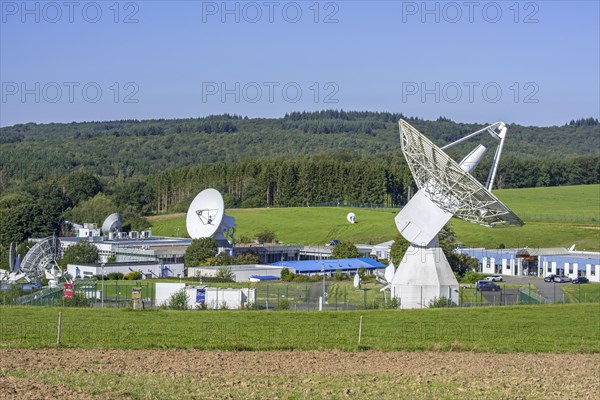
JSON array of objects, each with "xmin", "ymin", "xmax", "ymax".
[{"xmin": 0, "ymin": 0, "xmax": 600, "ymax": 126}]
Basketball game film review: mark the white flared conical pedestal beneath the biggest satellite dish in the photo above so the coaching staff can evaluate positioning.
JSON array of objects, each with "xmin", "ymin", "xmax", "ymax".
[{"xmin": 391, "ymin": 237, "xmax": 458, "ymax": 309}]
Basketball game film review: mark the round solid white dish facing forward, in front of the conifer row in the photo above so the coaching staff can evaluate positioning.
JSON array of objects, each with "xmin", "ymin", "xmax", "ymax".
[{"xmin": 185, "ymin": 189, "xmax": 235, "ymax": 243}]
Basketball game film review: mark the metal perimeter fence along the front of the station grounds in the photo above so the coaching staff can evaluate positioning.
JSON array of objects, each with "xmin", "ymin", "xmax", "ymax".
[{"xmin": 13, "ymin": 280, "xmax": 597, "ymax": 311}]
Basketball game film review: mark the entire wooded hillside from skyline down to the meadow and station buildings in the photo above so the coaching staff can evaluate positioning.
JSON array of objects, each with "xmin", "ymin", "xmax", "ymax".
[{"xmin": 0, "ymin": 110, "xmax": 600, "ymax": 267}]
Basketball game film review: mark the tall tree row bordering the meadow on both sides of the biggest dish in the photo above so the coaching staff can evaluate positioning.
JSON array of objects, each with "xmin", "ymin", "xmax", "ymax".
[{"xmin": 149, "ymin": 155, "xmax": 600, "ymax": 213}]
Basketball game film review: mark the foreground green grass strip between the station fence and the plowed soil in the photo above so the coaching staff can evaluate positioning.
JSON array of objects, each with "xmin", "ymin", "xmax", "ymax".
[{"xmin": 0, "ymin": 304, "xmax": 600, "ymax": 353}]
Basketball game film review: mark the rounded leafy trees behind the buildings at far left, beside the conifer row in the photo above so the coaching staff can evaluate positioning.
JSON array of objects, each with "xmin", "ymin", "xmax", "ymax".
[{"xmin": 0, "ymin": 170, "xmax": 155, "ymax": 269}]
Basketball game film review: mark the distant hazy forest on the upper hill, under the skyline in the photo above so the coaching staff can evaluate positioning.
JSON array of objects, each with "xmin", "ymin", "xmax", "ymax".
[{"xmin": 0, "ymin": 110, "xmax": 600, "ymax": 184}]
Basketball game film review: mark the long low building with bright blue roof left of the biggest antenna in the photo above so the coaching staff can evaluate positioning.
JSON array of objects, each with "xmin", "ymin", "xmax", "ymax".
[{"xmin": 271, "ymin": 257, "xmax": 385, "ymax": 276}]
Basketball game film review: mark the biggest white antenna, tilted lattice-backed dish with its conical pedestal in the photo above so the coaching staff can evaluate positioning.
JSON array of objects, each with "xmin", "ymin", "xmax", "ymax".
[{"xmin": 391, "ymin": 120, "xmax": 523, "ymax": 308}]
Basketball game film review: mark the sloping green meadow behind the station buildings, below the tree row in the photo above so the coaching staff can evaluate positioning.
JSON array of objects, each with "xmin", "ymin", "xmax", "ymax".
[{"xmin": 150, "ymin": 185, "xmax": 600, "ymax": 251}]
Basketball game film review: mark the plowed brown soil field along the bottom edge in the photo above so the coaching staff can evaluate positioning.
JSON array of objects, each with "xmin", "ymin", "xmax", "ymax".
[{"xmin": 0, "ymin": 349, "xmax": 600, "ymax": 399}]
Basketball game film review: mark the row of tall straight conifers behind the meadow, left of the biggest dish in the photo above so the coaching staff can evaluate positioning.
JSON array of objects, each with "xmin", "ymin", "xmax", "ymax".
[{"xmin": 150, "ymin": 158, "xmax": 411, "ymax": 212}]
